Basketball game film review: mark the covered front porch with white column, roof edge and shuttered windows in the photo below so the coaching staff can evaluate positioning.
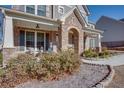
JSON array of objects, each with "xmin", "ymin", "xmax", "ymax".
[{"xmin": 3, "ymin": 10, "xmax": 61, "ymax": 65}]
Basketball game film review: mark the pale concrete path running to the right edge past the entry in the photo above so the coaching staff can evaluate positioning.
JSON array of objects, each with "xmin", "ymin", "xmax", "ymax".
[{"xmin": 82, "ymin": 54, "xmax": 124, "ymax": 66}]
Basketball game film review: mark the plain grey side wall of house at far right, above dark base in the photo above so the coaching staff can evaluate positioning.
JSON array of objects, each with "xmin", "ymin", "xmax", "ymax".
[{"xmin": 96, "ymin": 17, "xmax": 124, "ymax": 42}]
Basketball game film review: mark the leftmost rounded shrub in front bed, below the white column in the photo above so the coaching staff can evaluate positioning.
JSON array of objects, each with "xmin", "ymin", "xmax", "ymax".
[{"xmin": 7, "ymin": 54, "xmax": 36, "ymax": 75}]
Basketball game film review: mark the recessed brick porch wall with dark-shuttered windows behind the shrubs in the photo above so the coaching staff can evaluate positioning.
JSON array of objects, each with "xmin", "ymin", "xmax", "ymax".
[{"xmin": 14, "ymin": 27, "xmax": 59, "ymax": 52}]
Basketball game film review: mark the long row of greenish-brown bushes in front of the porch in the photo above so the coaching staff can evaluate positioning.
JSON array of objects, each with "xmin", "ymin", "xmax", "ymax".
[{"xmin": 4, "ymin": 50, "xmax": 80, "ymax": 80}]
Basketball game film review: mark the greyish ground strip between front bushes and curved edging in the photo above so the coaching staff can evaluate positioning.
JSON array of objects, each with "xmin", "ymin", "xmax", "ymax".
[{"xmin": 17, "ymin": 64, "xmax": 109, "ymax": 88}]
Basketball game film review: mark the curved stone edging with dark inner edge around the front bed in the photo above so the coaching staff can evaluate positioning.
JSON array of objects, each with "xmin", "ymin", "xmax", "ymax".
[{"xmin": 84, "ymin": 62, "xmax": 115, "ymax": 88}]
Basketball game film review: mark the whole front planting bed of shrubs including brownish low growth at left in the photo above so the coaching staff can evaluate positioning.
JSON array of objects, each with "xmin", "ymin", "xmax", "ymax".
[{"xmin": 0, "ymin": 50, "xmax": 80, "ymax": 87}]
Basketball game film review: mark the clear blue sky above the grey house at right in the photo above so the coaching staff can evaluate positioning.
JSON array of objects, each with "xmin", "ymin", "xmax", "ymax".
[{"xmin": 88, "ymin": 5, "xmax": 124, "ymax": 23}]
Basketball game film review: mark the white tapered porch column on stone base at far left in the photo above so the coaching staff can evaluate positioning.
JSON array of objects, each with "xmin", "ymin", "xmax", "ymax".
[{"xmin": 3, "ymin": 16, "xmax": 15, "ymax": 66}]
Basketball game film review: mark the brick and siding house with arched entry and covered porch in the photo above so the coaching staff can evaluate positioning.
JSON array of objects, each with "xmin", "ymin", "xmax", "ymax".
[{"xmin": 1, "ymin": 5, "xmax": 102, "ymax": 64}]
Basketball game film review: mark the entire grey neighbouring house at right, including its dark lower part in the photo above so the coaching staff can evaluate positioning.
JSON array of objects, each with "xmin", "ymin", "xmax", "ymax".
[{"xmin": 96, "ymin": 16, "xmax": 124, "ymax": 48}]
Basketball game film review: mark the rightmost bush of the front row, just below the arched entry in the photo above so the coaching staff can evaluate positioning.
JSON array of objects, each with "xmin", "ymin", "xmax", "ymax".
[{"xmin": 59, "ymin": 50, "xmax": 80, "ymax": 74}]
